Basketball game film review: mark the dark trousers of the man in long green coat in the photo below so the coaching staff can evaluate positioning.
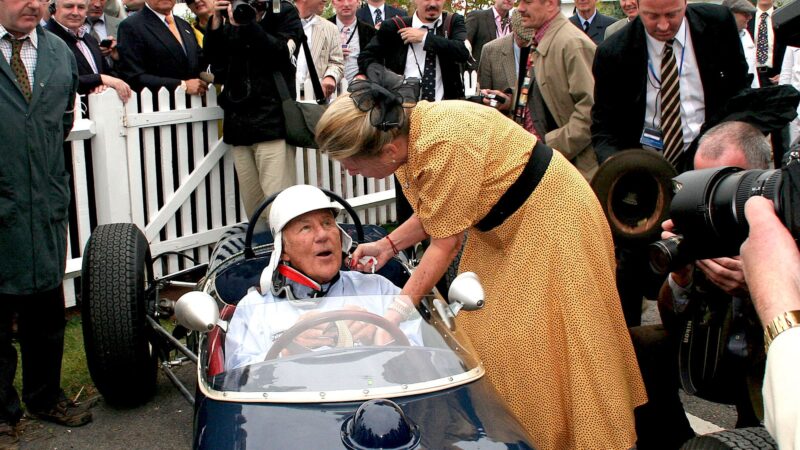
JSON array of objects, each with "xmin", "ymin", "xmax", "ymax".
[{"xmin": 0, "ymin": 284, "xmax": 66, "ymax": 423}]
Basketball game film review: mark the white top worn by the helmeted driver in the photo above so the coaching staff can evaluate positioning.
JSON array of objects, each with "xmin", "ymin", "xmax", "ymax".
[{"xmin": 225, "ymin": 271, "xmax": 422, "ymax": 370}]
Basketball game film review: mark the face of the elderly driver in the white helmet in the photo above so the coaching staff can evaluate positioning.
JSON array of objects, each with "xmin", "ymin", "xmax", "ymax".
[{"xmin": 281, "ymin": 209, "xmax": 342, "ymax": 283}]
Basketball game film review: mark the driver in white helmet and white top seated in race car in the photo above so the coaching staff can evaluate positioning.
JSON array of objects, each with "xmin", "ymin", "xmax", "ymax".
[{"xmin": 225, "ymin": 185, "xmax": 421, "ymax": 370}]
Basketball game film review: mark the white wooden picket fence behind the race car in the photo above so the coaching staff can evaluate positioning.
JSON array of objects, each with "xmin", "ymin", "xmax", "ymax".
[{"xmin": 65, "ymin": 82, "xmax": 395, "ymax": 306}]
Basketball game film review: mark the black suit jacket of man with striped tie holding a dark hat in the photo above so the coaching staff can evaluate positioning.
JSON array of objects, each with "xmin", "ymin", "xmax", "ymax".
[{"xmin": 592, "ymin": 3, "xmax": 750, "ymax": 170}]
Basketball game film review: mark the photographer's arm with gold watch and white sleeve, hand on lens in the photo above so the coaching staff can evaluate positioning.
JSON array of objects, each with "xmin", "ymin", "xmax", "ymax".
[{"xmin": 742, "ymin": 197, "xmax": 800, "ymax": 449}]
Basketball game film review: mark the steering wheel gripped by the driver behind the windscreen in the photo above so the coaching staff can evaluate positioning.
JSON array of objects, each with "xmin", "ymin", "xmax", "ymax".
[{"xmin": 264, "ymin": 309, "xmax": 411, "ymax": 361}]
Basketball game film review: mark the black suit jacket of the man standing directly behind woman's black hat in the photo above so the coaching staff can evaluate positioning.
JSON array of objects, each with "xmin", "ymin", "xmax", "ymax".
[{"xmin": 358, "ymin": 12, "xmax": 469, "ymax": 100}]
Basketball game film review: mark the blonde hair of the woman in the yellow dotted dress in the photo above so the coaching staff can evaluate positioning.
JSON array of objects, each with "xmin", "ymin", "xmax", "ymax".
[{"xmin": 316, "ymin": 93, "xmax": 409, "ymax": 159}]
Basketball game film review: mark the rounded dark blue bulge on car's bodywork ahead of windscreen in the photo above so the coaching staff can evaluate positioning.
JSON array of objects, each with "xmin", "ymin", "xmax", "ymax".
[{"xmin": 342, "ymin": 399, "xmax": 419, "ymax": 450}]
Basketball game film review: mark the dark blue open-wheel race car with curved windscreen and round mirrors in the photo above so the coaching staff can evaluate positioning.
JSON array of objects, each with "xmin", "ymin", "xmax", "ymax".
[{"xmin": 82, "ymin": 193, "xmax": 535, "ymax": 449}]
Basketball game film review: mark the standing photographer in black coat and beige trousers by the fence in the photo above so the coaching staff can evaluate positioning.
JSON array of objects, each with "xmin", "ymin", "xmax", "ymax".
[{"xmin": 204, "ymin": 0, "xmax": 303, "ymax": 223}]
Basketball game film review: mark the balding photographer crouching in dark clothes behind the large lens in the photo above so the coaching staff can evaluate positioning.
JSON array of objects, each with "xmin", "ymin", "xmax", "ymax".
[{"xmin": 631, "ymin": 122, "xmax": 771, "ymax": 449}]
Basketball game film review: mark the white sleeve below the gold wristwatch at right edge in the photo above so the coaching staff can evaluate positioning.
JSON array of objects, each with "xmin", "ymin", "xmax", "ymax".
[{"xmin": 762, "ymin": 328, "xmax": 800, "ymax": 450}]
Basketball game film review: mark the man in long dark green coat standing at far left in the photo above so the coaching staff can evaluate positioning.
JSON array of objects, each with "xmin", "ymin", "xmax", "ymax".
[{"xmin": 0, "ymin": 0, "xmax": 91, "ymax": 442}]
